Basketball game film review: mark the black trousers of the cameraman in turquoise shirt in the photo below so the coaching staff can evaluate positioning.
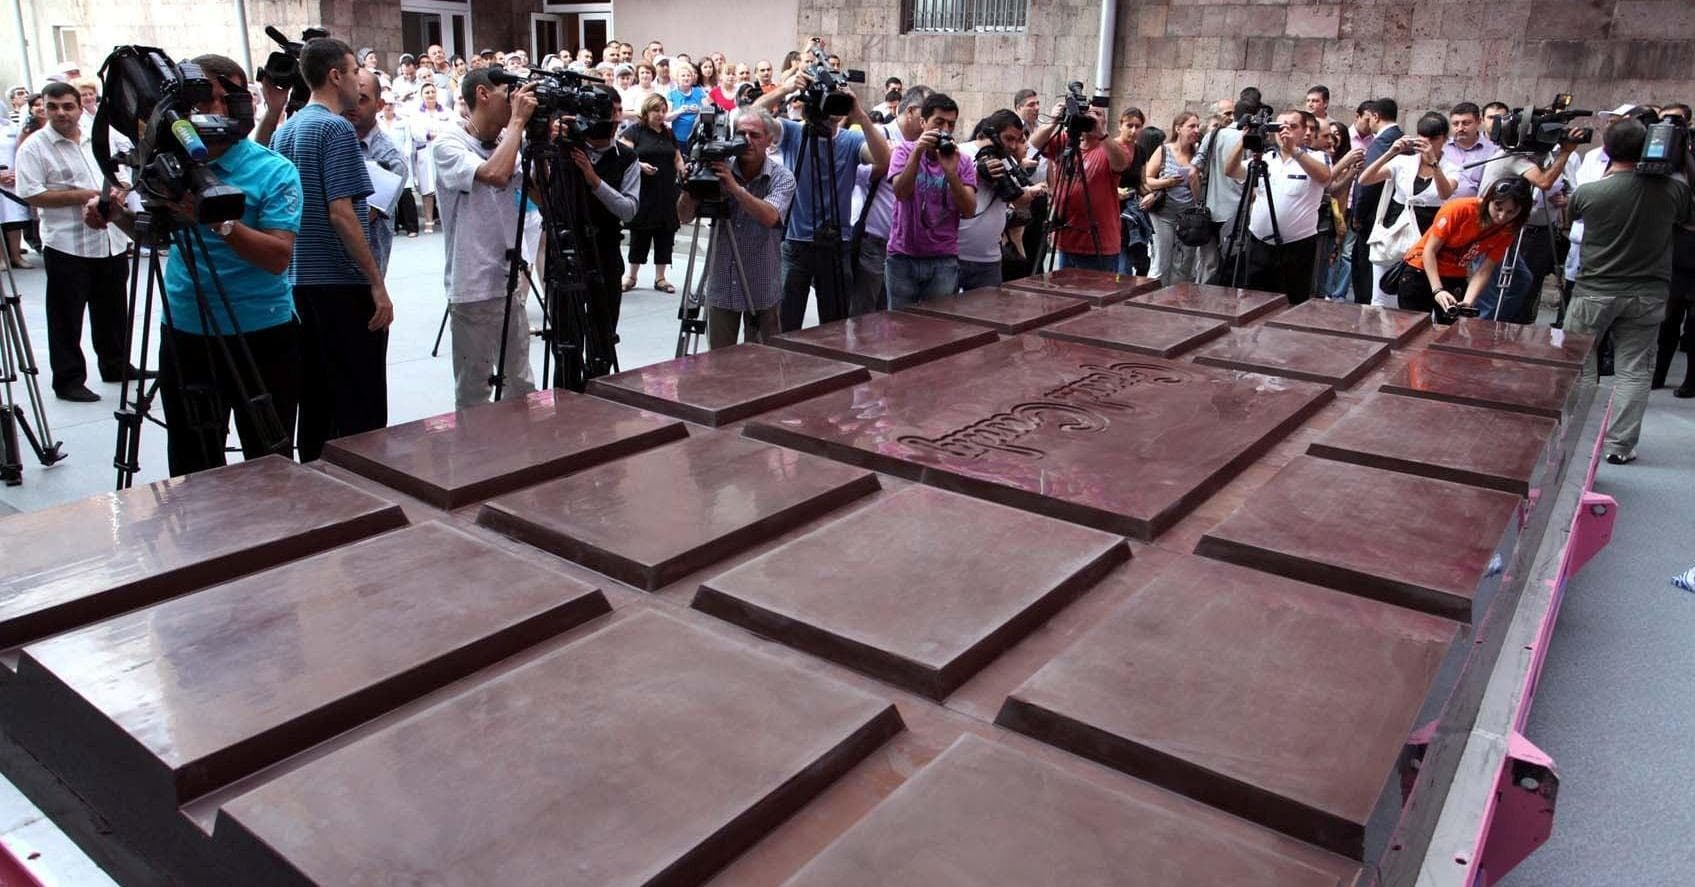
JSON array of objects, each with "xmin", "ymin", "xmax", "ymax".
[{"xmin": 159, "ymin": 321, "xmax": 300, "ymax": 477}]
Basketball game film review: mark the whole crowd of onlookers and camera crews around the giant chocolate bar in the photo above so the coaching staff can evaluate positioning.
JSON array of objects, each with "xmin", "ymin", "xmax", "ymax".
[{"xmin": 0, "ymin": 39, "xmax": 1695, "ymax": 475}]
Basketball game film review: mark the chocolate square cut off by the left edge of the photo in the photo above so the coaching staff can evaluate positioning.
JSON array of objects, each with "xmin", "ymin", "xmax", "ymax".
[{"xmin": 0, "ymin": 456, "xmax": 405, "ymax": 648}]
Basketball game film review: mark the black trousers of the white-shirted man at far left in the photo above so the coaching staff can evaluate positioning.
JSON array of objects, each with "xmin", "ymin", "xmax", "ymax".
[{"xmin": 42, "ymin": 248, "xmax": 129, "ymax": 392}]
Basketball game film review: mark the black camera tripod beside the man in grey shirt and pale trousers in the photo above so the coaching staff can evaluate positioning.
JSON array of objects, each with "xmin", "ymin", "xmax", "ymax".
[{"xmin": 488, "ymin": 127, "xmax": 619, "ymax": 400}]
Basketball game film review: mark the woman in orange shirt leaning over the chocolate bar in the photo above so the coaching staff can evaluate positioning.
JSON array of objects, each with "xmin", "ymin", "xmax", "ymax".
[{"xmin": 1400, "ymin": 176, "xmax": 1531, "ymax": 312}]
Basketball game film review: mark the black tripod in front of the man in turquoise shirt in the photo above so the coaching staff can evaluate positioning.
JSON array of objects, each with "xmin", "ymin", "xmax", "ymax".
[{"xmin": 112, "ymin": 207, "xmax": 293, "ymax": 490}]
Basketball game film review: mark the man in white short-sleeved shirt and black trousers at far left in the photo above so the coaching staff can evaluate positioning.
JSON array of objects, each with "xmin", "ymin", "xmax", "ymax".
[{"xmin": 17, "ymin": 83, "xmax": 136, "ymax": 404}]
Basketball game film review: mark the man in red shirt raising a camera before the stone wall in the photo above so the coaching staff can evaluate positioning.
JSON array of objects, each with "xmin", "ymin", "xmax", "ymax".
[{"xmin": 1031, "ymin": 90, "xmax": 1131, "ymax": 271}]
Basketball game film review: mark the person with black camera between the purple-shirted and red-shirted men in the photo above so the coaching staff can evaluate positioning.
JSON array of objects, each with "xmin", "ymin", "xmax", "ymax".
[{"xmin": 959, "ymin": 109, "xmax": 1048, "ymax": 290}]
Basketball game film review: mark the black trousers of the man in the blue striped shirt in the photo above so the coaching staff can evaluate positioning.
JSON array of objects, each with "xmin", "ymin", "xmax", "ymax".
[{"xmin": 295, "ymin": 283, "xmax": 388, "ymax": 461}]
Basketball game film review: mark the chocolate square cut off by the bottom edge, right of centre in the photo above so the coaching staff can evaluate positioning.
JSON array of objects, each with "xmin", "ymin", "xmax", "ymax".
[{"xmin": 790, "ymin": 736, "xmax": 1359, "ymax": 887}]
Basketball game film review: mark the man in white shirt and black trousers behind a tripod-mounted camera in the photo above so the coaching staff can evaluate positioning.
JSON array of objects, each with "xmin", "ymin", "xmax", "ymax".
[{"xmin": 1224, "ymin": 110, "xmax": 1331, "ymax": 305}]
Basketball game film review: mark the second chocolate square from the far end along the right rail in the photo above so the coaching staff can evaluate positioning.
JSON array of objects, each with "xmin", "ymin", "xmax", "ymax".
[{"xmin": 1381, "ymin": 351, "xmax": 1578, "ymax": 419}]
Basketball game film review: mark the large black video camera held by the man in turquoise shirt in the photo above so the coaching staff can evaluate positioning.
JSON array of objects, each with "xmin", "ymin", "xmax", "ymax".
[{"xmin": 93, "ymin": 46, "xmax": 253, "ymax": 224}]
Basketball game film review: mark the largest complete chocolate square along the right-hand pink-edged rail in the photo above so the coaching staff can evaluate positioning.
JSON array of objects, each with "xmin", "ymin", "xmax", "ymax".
[{"xmin": 997, "ymin": 558, "xmax": 1458, "ymax": 858}]
